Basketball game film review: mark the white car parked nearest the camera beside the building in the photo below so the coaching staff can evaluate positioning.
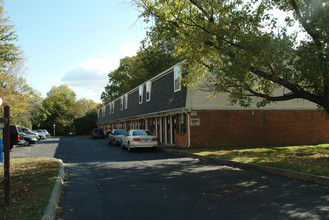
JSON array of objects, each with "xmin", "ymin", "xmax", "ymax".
[{"xmin": 121, "ymin": 130, "xmax": 158, "ymax": 151}]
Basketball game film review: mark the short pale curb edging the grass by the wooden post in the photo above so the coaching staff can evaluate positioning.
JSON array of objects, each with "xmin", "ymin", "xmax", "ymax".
[{"xmin": 41, "ymin": 159, "xmax": 65, "ymax": 220}]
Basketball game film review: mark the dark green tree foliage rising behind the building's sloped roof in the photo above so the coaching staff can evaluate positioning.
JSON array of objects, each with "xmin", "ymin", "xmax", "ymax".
[{"xmin": 101, "ymin": 41, "xmax": 181, "ymax": 103}]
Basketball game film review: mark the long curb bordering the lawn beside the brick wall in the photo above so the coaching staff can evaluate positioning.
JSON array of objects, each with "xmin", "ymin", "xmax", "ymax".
[{"xmin": 162, "ymin": 148, "xmax": 329, "ymax": 186}]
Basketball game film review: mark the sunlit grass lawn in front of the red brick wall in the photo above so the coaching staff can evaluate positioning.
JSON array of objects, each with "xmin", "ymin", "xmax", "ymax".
[{"xmin": 187, "ymin": 144, "xmax": 329, "ymax": 177}]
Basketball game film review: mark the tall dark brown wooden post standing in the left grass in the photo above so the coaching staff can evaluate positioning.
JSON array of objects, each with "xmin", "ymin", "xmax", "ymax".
[{"xmin": 3, "ymin": 106, "xmax": 10, "ymax": 205}]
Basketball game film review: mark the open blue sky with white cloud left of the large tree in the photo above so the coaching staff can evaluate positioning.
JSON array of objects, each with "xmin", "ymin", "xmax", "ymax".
[{"xmin": 4, "ymin": 0, "xmax": 146, "ymax": 102}]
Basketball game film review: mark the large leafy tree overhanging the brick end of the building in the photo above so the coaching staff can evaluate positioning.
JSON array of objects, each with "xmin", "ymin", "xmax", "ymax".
[{"xmin": 135, "ymin": 0, "xmax": 329, "ymax": 113}]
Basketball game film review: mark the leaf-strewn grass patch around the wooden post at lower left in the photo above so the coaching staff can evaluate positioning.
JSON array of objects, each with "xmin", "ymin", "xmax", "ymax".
[{"xmin": 0, "ymin": 158, "xmax": 59, "ymax": 220}]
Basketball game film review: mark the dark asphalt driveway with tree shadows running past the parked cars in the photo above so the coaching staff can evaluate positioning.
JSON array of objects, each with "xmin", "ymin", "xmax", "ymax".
[{"xmin": 11, "ymin": 137, "xmax": 329, "ymax": 220}]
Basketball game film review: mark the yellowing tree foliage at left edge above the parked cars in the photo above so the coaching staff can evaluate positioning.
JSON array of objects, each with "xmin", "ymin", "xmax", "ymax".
[{"xmin": 0, "ymin": 2, "xmax": 41, "ymax": 127}]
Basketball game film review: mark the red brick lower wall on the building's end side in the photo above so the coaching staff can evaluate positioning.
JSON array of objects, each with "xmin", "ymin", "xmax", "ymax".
[{"xmin": 191, "ymin": 110, "xmax": 329, "ymax": 147}]
